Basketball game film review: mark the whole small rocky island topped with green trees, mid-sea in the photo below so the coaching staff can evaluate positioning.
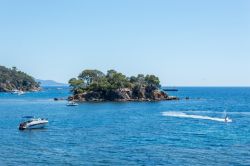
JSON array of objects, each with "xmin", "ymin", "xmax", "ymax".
[{"xmin": 68, "ymin": 70, "xmax": 178, "ymax": 102}]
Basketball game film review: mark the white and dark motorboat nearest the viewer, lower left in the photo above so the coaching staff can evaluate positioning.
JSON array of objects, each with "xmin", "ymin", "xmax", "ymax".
[{"xmin": 19, "ymin": 116, "xmax": 49, "ymax": 130}]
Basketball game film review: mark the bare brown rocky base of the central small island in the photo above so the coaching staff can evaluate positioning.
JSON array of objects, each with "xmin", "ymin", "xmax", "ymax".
[{"xmin": 69, "ymin": 88, "xmax": 178, "ymax": 102}]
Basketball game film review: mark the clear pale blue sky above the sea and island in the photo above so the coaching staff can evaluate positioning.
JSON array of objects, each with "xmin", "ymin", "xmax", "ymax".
[{"xmin": 0, "ymin": 0, "xmax": 250, "ymax": 86}]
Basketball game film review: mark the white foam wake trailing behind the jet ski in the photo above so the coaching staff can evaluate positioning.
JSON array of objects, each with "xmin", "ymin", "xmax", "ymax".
[{"xmin": 162, "ymin": 112, "xmax": 232, "ymax": 122}]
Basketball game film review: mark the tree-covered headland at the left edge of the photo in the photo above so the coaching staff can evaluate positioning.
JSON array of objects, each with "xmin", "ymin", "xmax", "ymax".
[{"xmin": 0, "ymin": 66, "xmax": 40, "ymax": 92}]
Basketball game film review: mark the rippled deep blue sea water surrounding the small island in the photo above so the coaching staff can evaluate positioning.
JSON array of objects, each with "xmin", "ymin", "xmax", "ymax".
[{"xmin": 0, "ymin": 87, "xmax": 250, "ymax": 166}]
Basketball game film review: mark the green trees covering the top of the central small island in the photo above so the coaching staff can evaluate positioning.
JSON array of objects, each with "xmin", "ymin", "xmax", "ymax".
[{"xmin": 69, "ymin": 70, "xmax": 160, "ymax": 95}]
